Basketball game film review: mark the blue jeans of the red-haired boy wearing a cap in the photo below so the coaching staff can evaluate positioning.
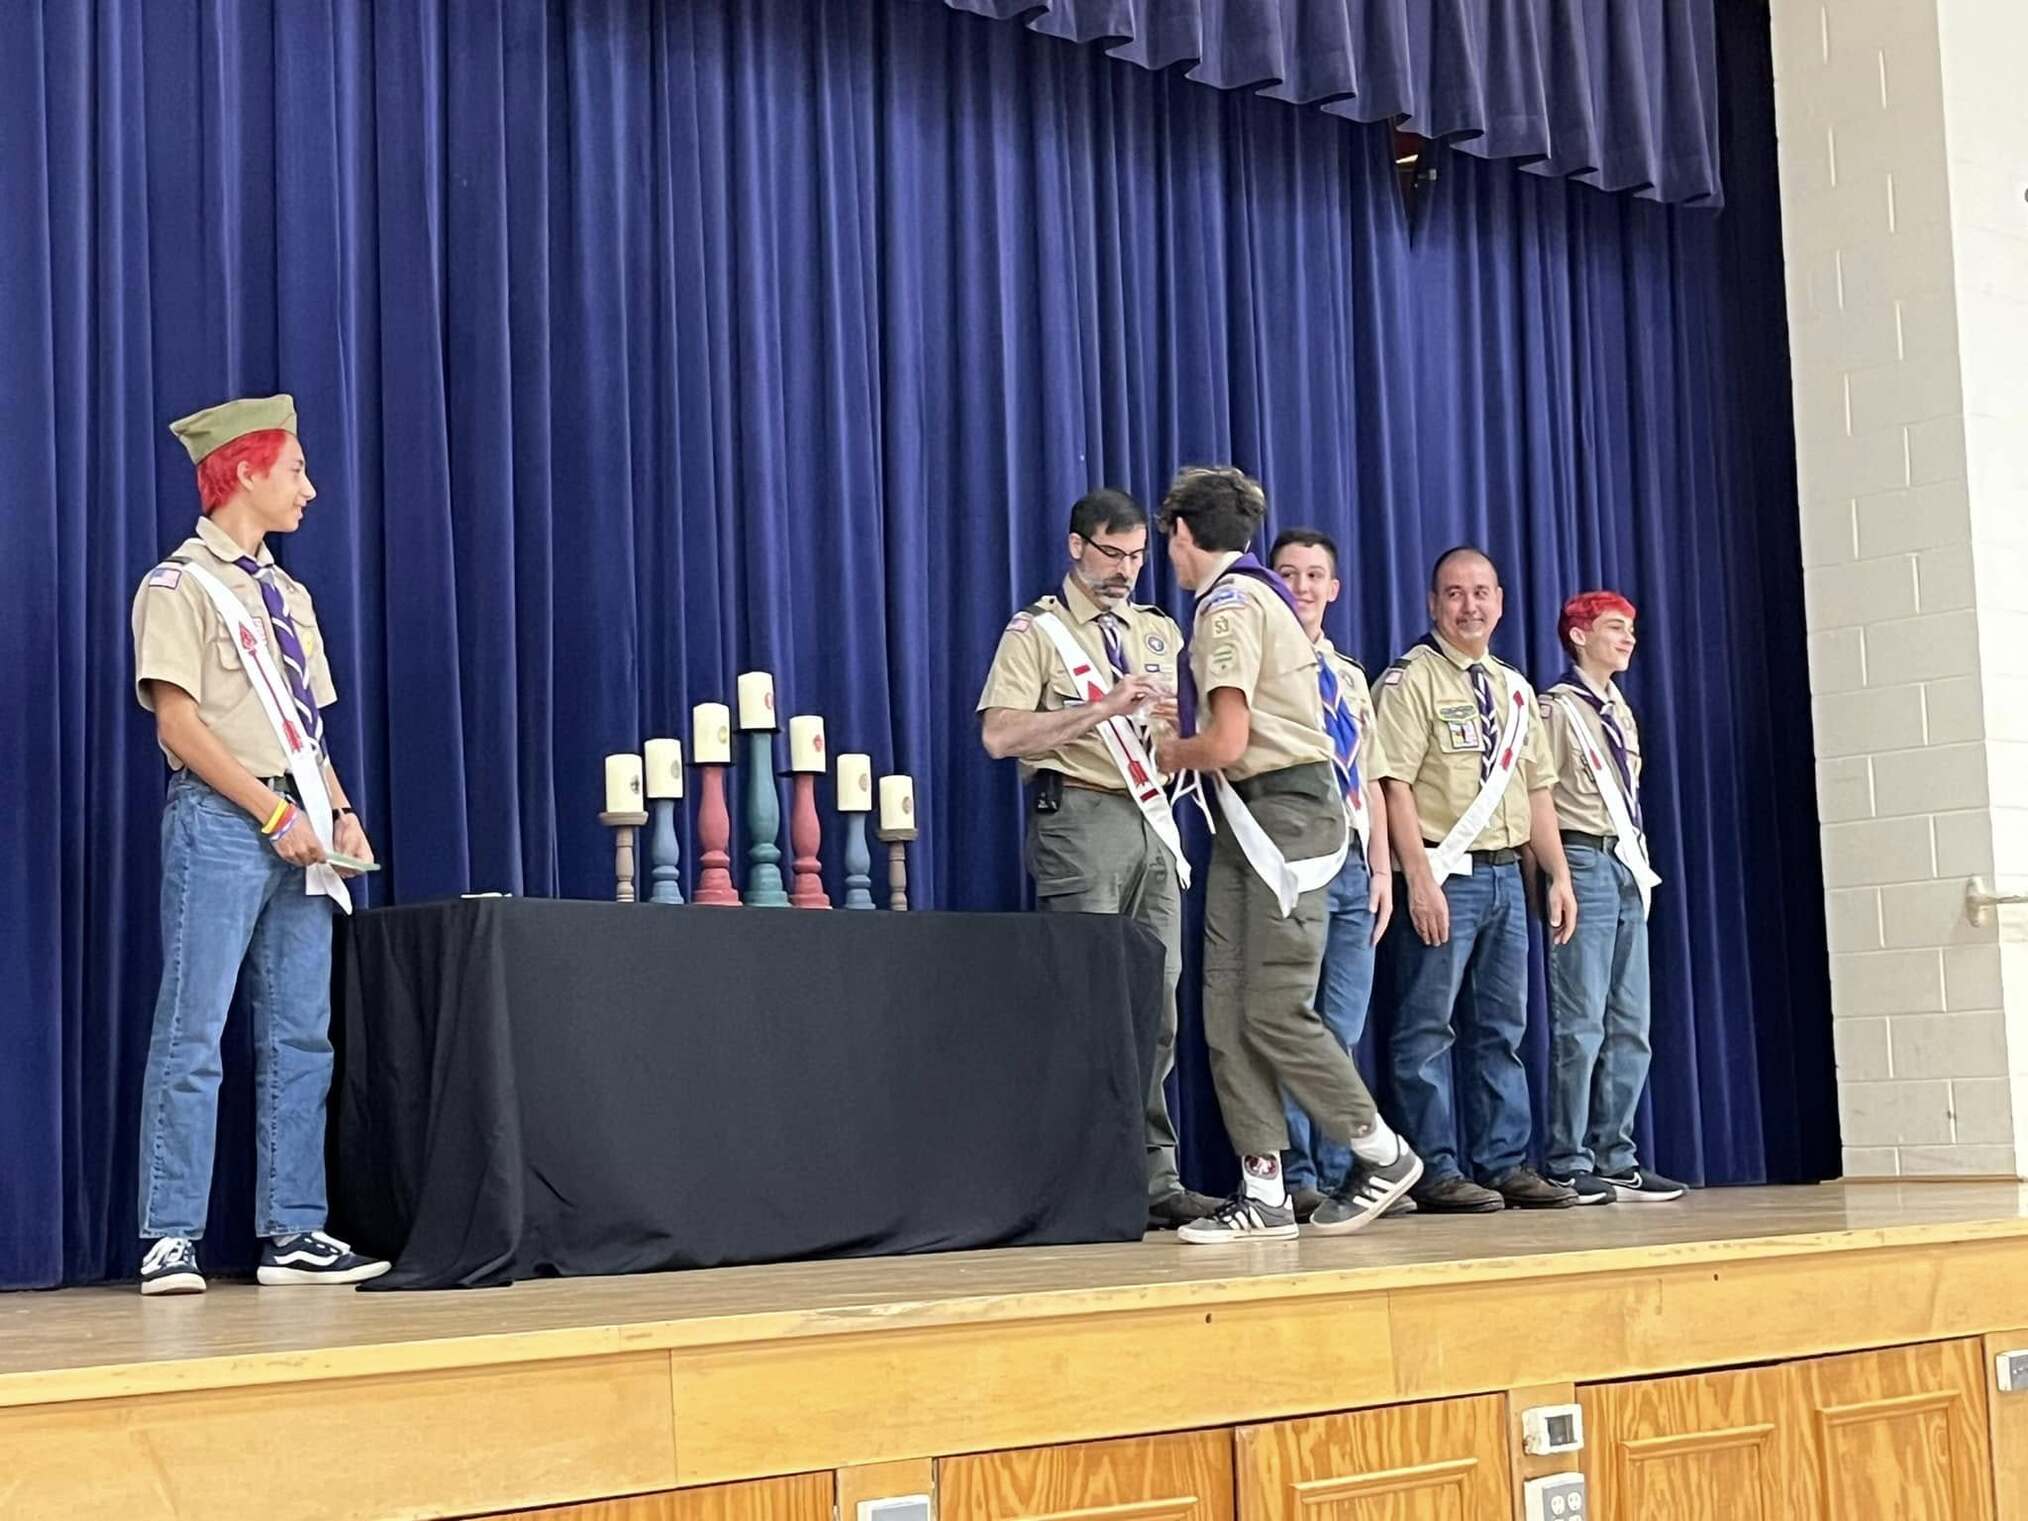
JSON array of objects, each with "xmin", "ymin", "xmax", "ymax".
[{"xmin": 140, "ymin": 771, "xmax": 333, "ymax": 1239}]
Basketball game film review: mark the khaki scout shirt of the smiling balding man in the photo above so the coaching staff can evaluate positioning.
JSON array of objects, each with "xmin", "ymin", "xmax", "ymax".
[{"xmin": 1375, "ymin": 635, "xmax": 1555, "ymax": 850}]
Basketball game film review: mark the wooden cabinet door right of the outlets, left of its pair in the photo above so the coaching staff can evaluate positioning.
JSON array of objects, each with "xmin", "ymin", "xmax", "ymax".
[{"xmin": 1578, "ymin": 1367, "xmax": 1819, "ymax": 1521}]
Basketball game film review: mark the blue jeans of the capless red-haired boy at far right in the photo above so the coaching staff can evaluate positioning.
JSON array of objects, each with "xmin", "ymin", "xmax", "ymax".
[{"xmin": 1547, "ymin": 844, "xmax": 1651, "ymax": 1178}]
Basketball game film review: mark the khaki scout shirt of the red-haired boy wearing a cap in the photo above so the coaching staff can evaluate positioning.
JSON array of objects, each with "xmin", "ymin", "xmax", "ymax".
[{"xmin": 134, "ymin": 517, "xmax": 339, "ymax": 777}]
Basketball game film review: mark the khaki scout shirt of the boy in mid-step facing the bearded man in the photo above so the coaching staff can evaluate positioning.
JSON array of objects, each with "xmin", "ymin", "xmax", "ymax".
[{"xmin": 1190, "ymin": 554, "xmax": 1330, "ymax": 781}]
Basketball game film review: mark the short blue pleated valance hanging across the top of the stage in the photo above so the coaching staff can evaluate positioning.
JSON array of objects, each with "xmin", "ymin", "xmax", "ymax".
[{"xmin": 935, "ymin": 0, "xmax": 1722, "ymax": 205}]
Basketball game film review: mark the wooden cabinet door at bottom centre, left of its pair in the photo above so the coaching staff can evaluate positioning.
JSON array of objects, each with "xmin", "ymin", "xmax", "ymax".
[{"xmin": 937, "ymin": 1432, "xmax": 1233, "ymax": 1521}]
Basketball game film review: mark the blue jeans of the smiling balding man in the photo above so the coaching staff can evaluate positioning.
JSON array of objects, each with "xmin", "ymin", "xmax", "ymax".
[{"xmin": 1387, "ymin": 864, "xmax": 1525, "ymax": 1182}]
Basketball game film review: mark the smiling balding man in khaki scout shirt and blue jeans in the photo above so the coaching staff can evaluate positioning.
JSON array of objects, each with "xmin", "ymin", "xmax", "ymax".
[{"xmin": 1375, "ymin": 546, "xmax": 1578, "ymax": 1215}]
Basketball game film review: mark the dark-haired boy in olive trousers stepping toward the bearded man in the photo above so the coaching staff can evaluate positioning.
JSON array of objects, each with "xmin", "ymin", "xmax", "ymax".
[{"xmin": 1156, "ymin": 466, "xmax": 1422, "ymax": 1245}]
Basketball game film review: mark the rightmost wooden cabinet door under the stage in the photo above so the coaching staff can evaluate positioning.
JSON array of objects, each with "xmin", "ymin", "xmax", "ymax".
[{"xmin": 1793, "ymin": 1341, "xmax": 1994, "ymax": 1521}]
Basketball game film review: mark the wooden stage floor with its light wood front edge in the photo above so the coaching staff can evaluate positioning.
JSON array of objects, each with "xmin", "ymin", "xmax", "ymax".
[{"xmin": 0, "ymin": 1182, "xmax": 2028, "ymax": 1513}]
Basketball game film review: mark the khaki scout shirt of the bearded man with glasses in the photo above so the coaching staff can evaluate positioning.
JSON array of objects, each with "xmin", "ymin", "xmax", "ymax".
[{"xmin": 977, "ymin": 576, "xmax": 1182, "ymax": 793}]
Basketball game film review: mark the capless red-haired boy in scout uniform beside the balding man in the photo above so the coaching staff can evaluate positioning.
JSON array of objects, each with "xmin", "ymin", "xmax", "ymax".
[{"xmin": 1541, "ymin": 592, "xmax": 1683, "ymax": 1205}]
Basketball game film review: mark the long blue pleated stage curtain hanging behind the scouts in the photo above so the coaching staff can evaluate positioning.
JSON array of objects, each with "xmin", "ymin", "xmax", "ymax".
[{"xmin": 0, "ymin": 0, "xmax": 1835, "ymax": 1286}]
